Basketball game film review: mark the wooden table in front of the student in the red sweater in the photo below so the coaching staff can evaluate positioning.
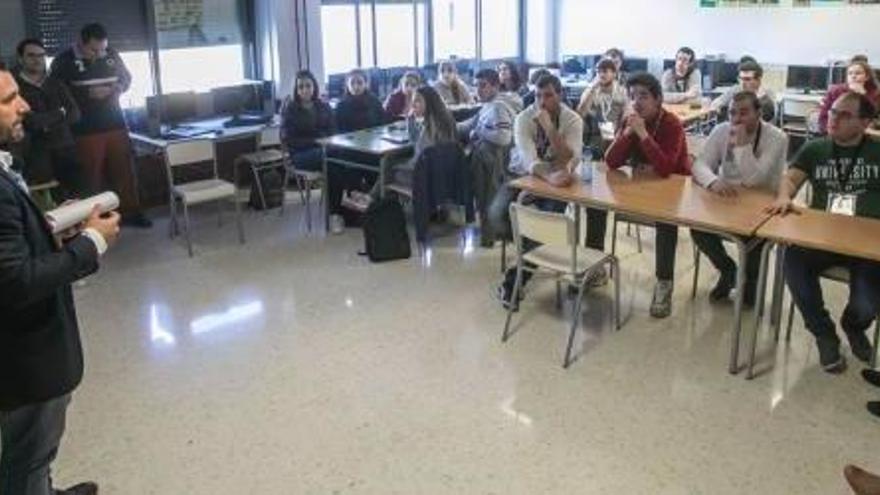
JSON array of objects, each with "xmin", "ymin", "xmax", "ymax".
[{"xmin": 510, "ymin": 164, "xmax": 773, "ymax": 374}]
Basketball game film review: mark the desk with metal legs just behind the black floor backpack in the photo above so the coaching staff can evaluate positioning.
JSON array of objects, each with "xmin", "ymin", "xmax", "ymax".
[{"xmin": 318, "ymin": 126, "xmax": 413, "ymax": 229}]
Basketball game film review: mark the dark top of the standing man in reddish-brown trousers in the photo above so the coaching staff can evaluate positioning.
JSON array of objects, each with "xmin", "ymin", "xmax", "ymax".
[{"xmin": 49, "ymin": 46, "xmax": 131, "ymax": 136}]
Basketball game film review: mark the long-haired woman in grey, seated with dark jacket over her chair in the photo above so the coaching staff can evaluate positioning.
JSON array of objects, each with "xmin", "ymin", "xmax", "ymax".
[{"xmin": 360, "ymin": 86, "xmax": 457, "ymax": 202}]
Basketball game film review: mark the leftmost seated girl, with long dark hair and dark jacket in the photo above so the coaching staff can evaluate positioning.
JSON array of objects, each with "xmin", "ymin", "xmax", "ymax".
[{"xmin": 281, "ymin": 70, "xmax": 334, "ymax": 171}]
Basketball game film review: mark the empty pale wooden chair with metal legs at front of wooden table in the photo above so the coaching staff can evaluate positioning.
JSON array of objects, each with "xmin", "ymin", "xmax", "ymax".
[{"xmin": 501, "ymin": 203, "xmax": 620, "ymax": 368}]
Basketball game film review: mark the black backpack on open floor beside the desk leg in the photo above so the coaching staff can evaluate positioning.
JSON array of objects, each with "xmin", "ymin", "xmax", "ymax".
[{"xmin": 363, "ymin": 197, "xmax": 411, "ymax": 262}]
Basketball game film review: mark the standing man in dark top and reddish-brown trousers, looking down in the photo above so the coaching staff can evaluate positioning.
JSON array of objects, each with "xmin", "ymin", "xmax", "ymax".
[{"xmin": 50, "ymin": 24, "xmax": 152, "ymax": 228}]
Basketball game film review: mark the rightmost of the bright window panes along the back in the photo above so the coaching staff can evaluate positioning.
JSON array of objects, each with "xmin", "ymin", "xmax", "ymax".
[{"xmin": 480, "ymin": 0, "xmax": 519, "ymax": 59}]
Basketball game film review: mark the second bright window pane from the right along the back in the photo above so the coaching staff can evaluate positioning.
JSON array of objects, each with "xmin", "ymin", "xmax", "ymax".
[{"xmin": 431, "ymin": 0, "xmax": 477, "ymax": 60}]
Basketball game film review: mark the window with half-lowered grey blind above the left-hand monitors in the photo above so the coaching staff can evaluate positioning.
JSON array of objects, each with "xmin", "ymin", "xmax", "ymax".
[{"xmin": 153, "ymin": 0, "xmax": 245, "ymax": 93}]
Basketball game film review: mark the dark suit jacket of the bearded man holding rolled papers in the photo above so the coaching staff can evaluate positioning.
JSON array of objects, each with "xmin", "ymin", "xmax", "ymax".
[{"xmin": 0, "ymin": 170, "xmax": 98, "ymax": 410}]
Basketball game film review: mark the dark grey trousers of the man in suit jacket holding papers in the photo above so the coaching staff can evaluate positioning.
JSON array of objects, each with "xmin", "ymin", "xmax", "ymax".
[{"xmin": 0, "ymin": 394, "xmax": 70, "ymax": 495}]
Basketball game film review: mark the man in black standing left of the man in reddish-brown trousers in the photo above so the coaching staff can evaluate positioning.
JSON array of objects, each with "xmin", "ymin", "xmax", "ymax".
[{"xmin": 15, "ymin": 38, "xmax": 85, "ymax": 201}]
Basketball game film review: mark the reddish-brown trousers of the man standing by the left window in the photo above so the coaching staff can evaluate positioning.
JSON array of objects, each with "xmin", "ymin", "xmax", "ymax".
[{"xmin": 76, "ymin": 129, "xmax": 140, "ymax": 215}]
